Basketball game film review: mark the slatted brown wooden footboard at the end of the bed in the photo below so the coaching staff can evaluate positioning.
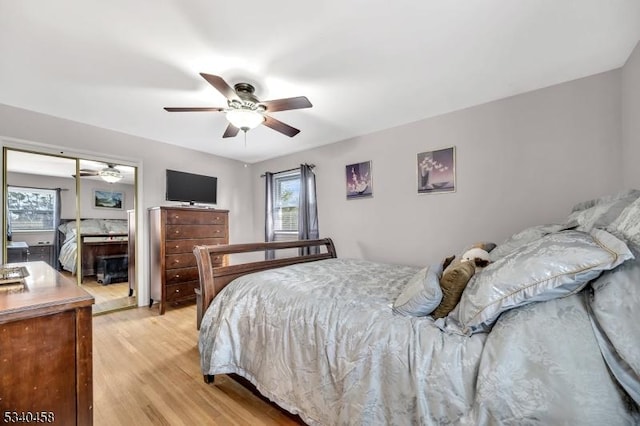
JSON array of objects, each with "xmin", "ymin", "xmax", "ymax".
[{"xmin": 193, "ymin": 238, "xmax": 336, "ymax": 330}]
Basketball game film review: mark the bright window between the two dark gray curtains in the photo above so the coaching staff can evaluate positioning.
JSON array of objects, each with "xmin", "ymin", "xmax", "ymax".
[{"xmin": 273, "ymin": 171, "xmax": 300, "ymax": 236}]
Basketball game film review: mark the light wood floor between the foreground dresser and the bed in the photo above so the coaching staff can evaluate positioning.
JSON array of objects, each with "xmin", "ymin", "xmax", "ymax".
[{"xmin": 93, "ymin": 305, "xmax": 304, "ymax": 426}]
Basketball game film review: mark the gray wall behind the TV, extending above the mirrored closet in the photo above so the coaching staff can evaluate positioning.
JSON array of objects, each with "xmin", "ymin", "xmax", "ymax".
[{"xmin": 0, "ymin": 105, "xmax": 254, "ymax": 305}]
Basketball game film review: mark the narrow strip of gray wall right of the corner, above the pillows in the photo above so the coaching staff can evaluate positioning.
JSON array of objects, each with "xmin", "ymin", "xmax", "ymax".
[{"xmin": 622, "ymin": 43, "xmax": 640, "ymax": 188}]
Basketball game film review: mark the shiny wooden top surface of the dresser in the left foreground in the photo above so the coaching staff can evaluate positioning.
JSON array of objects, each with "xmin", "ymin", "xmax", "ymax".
[{"xmin": 0, "ymin": 261, "xmax": 94, "ymax": 324}]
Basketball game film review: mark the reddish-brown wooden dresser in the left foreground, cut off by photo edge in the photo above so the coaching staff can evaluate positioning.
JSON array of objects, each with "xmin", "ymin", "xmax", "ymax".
[{"xmin": 0, "ymin": 261, "xmax": 93, "ymax": 426}]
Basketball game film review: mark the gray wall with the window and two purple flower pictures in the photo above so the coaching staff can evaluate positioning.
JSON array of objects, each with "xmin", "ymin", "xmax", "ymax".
[{"xmin": 253, "ymin": 70, "xmax": 622, "ymax": 265}]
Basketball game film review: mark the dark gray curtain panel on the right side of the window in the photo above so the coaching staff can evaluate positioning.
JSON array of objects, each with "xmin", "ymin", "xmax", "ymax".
[{"xmin": 298, "ymin": 164, "xmax": 320, "ymax": 255}]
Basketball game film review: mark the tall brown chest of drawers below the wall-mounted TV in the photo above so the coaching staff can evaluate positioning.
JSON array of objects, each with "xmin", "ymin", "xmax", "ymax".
[{"xmin": 149, "ymin": 207, "xmax": 229, "ymax": 315}]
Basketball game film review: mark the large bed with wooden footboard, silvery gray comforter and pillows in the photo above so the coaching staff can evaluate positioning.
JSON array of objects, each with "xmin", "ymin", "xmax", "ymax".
[{"xmin": 194, "ymin": 191, "xmax": 640, "ymax": 425}]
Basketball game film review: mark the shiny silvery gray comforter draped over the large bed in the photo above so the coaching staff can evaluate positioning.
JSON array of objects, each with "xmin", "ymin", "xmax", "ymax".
[{"xmin": 199, "ymin": 259, "xmax": 640, "ymax": 425}]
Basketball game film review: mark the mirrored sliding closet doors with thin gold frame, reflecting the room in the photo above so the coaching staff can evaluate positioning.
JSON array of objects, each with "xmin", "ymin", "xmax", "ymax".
[{"xmin": 4, "ymin": 148, "xmax": 136, "ymax": 314}]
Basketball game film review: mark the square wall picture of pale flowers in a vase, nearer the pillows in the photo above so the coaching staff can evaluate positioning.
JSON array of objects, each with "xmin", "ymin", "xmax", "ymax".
[{"xmin": 416, "ymin": 146, "xmax": 456, "ymax": 194}]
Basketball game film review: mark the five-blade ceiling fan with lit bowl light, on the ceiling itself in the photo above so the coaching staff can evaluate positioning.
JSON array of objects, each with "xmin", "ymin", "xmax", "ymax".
[{"xmin": 165, "ymin": 73, "xmax": 313, "ymax": 138}]
